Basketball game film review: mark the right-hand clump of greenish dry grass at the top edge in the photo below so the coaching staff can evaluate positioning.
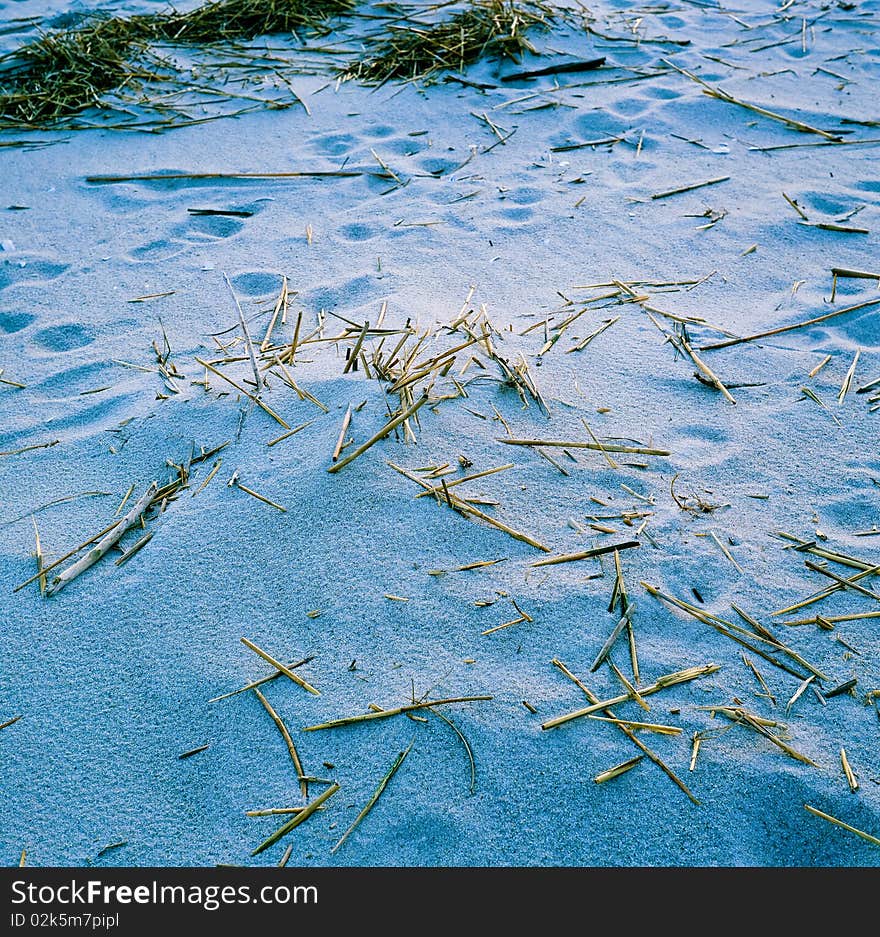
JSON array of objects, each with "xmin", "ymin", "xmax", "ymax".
[{"xmin": 342, "ymin": 0, "xmax": 554, "ymax": 84}]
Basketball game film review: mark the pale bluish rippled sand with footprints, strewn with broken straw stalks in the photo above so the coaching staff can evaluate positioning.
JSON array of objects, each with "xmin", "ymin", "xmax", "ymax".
[{"xmin": 0, "ymin": 0, "xmax": 880, "ymax": 866}]
